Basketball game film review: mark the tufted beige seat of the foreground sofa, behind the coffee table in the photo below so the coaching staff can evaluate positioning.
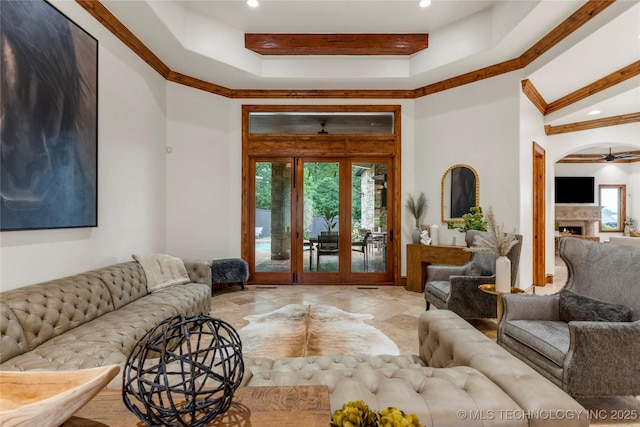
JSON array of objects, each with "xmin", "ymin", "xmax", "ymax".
[{"xmin": 245, "ymin": 355, "xmax": 527, "ymax": 426}]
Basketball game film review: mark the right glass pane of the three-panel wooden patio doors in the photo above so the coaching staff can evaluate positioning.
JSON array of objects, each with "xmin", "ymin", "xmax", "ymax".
[{"xmin": 351, "ymin": 162, "xmax": 388, "ymax": 273}]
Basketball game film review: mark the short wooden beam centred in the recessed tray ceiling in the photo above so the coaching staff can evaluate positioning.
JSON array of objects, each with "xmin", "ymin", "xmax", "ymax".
[{"xmin": 244, "ymin": 33, "xmax": 429, "ymax": 55}]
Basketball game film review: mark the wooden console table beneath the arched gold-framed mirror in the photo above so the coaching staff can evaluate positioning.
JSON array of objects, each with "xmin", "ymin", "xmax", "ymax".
[{"xmin": 406, "ymin": 245, "xmax": 471, "ymax": 292}]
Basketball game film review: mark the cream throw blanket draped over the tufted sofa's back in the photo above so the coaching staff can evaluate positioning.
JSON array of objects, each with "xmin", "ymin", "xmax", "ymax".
[{"xmin": 133, "ymin": 254, "xmax": 190, "ymax": 292}]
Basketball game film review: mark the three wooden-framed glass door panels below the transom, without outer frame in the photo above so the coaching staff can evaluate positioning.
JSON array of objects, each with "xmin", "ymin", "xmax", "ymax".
[{"xmin": 249, "ymin": 157, "xmax": 394, "ymax": 284}]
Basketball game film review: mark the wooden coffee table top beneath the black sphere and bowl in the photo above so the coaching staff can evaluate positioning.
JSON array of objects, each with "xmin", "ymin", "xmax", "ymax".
[{"xmin": 63, "ymin": 385, "xmax": 331, "ymax": 427}]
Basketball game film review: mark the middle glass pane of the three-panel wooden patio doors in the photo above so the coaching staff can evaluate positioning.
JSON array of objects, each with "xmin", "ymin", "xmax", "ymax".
[{"xmin": 302, "ymin": 161, "xmax": 341, "ymax": 273}]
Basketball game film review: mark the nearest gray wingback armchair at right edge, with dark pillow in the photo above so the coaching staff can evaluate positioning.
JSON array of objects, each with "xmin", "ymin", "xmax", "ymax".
[{"xmin": 498, "ymin": 238, "xmax": 640, "ymax": 397}]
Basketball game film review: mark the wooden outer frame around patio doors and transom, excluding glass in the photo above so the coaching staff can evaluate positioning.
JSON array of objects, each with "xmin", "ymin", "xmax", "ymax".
[{"xmin": 241, "ymin": 105, "xmax": 402, "ymax": 285}]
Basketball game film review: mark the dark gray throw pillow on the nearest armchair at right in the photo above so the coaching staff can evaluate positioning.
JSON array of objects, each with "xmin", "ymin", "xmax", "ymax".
[{"xmin": 560, "ymin": 290, "xmax": 631, "ymax": 322}]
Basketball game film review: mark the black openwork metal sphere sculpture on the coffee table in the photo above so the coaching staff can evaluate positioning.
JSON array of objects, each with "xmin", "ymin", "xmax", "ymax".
[{"xmin": 122, "ymin": 314, "xmax": 244, "ymax": 427}]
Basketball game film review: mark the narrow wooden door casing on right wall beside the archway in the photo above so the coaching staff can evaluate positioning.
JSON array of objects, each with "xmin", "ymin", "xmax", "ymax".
[{"xmin": 532, "ymin": 141, "xmax": 547, "ymax": 292}]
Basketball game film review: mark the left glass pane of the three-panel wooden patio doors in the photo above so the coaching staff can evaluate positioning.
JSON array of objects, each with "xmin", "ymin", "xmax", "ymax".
[{"xmin": 254, "ymin": 161, "xmax": 291, "ymax": 272}]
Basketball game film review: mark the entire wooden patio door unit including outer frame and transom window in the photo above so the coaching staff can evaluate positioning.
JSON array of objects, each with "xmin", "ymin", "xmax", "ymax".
[{"xmin": 241, "ymin": 105, "xmax": 401, "ymax": 284}]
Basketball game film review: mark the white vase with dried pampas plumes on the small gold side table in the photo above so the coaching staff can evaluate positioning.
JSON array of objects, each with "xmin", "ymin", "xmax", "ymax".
[{"xmin": 466, "ymin": 208, "xmax": 518, "ymax": 293}]
